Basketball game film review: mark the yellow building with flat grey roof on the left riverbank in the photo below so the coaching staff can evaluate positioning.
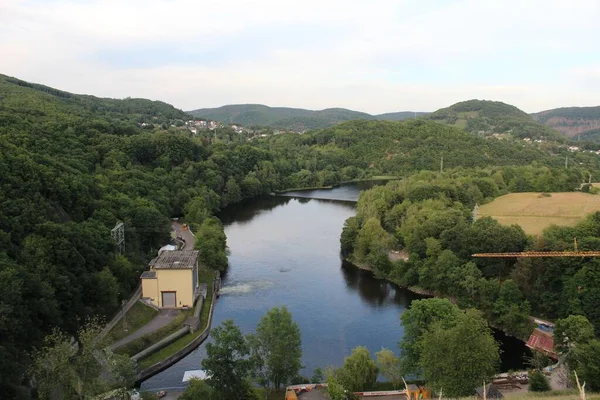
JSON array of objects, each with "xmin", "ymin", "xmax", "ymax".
[{"xmin": 141, "ymin": 250, "xmax": 199, "ymax": 308}]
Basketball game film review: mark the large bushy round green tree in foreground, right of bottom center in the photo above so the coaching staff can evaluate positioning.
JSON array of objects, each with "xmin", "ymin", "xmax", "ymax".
[{"xmin": 419, "ymin": 309, "xmax": 500, "ymax": 397}]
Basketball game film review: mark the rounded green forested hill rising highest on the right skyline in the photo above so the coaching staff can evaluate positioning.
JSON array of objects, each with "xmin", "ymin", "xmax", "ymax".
[{"xmin": 424, "ymin": 100, "xmax": 565, "ymax": 141}]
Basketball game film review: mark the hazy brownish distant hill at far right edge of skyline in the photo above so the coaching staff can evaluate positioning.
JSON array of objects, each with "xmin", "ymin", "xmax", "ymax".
[{"xmin": 532, "ymin": 106, "xmax": 600, "ymax": 142}]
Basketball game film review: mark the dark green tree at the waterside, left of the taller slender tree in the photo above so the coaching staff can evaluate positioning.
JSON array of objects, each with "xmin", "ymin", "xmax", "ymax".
[{"xmin": 202, "ymin": 320, "xmax": 252, "ymax": 399}]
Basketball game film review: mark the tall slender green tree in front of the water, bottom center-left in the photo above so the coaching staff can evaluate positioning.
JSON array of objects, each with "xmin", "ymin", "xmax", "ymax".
[{"xmin": 249, "ymin": 306, "xmax": 302, "ymax": 390}]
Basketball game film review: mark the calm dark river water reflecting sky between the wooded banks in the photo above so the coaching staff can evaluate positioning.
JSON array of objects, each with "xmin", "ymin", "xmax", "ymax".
[{"xmin": 142, "ymin": 182, "xmax": 526, "ymax": 390}]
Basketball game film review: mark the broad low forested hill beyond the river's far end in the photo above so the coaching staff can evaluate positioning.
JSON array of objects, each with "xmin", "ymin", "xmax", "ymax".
[{"xmin": 266, "ymin": 120, "xmax": 584, "ymax": 179}]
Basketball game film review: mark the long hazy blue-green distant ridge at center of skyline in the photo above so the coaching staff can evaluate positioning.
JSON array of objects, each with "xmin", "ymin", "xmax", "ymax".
[{"xmin": 188, "ymin": 104, "xmax": 427, "ymax": 131}]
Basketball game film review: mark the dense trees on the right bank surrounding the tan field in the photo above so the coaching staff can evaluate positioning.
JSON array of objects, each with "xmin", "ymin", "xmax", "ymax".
[{"xmin": 341, "ymin": 167, "xmax": 600, "ymax": 338}]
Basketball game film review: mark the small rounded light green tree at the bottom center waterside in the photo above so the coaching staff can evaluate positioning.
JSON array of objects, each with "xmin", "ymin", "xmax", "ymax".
[{"xmin": 339, "ymin": 346, "xmax": 379, "ymax": 392}]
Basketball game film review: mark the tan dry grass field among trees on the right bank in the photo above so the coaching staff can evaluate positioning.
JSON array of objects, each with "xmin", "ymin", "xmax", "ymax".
[{"xmin": 479, "ymin": 192, "xmax": 600, "ymax": 235}]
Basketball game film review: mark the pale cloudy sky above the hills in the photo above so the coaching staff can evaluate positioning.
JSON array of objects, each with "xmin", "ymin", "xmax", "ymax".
[{"xmin": 0, "ymin": 0, "xmax": 600, "ymax": 114}]
